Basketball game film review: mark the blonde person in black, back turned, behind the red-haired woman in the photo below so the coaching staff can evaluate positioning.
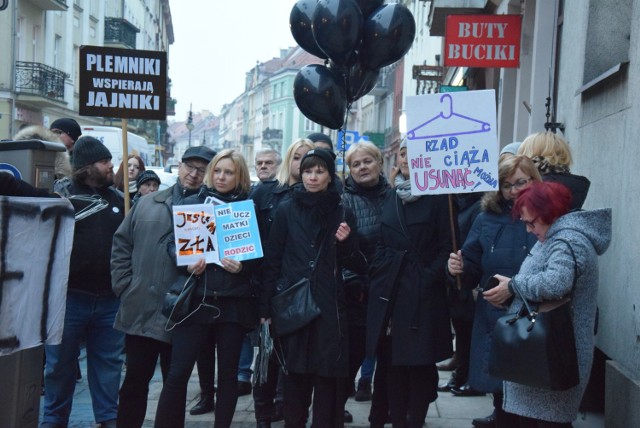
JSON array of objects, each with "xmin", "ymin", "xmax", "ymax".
[{"xmin": 518, "ymin": 131, "xmax": 591, "ymax": 210}]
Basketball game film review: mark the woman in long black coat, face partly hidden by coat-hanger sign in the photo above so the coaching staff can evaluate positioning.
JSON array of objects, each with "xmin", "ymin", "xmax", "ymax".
[{"xmin": 367, "ymin": 141, "xmax": 455, "ymax": 428}]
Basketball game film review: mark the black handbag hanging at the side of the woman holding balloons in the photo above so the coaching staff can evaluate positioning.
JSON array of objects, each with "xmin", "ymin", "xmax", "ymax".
[{"xmin": 271, "ymin": 234, "xmax": 324, "ymax": 337}]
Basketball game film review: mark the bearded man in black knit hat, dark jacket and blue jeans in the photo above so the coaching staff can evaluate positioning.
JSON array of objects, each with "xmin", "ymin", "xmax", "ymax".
[{"xmin": 41, "ymin": 136, "xmax": 124, "ymax": 428}]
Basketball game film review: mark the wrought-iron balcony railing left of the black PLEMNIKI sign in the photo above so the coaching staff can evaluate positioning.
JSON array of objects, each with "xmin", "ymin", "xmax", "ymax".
[{"xmin": 16, "ymin": 61, "xmax": 69, "ymax": 101}]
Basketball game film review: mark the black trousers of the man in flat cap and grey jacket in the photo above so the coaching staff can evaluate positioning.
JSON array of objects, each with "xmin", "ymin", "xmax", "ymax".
[{"xmin": 117, "ymin": 334, "xmax": 171, "ymax": 428}]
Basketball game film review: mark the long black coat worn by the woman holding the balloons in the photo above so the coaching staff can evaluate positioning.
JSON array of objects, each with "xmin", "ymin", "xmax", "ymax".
[{"xmin": 260, "ymin": 185, "xmax": 363, "ymax": 377}]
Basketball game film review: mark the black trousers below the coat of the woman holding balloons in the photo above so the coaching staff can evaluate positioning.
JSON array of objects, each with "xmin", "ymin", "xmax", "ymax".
[{"xmin": 284, "ymin": 373, "xmax": 345, "ymax": 428}]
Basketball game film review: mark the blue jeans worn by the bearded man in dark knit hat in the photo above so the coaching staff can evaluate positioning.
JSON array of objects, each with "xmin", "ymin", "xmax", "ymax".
[{"xmin": 42, "ymin": 290, "xmax": 124, "ymax": 426}]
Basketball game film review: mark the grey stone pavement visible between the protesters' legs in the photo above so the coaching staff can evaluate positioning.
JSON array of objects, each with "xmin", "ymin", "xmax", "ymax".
[{"xmin": 40, "ymin": 350, "xmax": 604, "ymax": 428}]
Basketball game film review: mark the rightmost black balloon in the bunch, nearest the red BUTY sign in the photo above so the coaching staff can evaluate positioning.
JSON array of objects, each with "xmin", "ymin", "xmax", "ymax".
[{"xmin": 362, "ymin": 3, "xmax": 416, "ymax": 69}]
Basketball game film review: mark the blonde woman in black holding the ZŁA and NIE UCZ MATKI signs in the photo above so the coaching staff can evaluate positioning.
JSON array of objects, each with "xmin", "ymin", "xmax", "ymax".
[{"xmin": 155, "ymin": 149, "xmax": 258, "ymax": 428}]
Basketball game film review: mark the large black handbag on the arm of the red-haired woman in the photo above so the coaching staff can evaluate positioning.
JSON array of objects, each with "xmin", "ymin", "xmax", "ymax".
[{"xmin": 489, "ymin": 241, "xmax": 580, "ymax": 391}]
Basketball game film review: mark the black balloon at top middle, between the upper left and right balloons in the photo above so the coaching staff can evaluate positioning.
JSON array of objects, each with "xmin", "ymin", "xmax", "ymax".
[{"xmin": 311, "ymin": 0, "xmax": 364, "ymax": 64}]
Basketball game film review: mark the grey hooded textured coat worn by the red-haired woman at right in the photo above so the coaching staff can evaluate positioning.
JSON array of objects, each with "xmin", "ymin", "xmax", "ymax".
[{"xmin": 503, "ymin": 209, "xmax": 611, "ymax": 423}]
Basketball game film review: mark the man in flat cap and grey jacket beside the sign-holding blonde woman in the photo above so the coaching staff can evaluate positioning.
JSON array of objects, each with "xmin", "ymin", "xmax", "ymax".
[{"xmin": 111, "ymin": 146, "xmax": 216, "ymax": 427}]
